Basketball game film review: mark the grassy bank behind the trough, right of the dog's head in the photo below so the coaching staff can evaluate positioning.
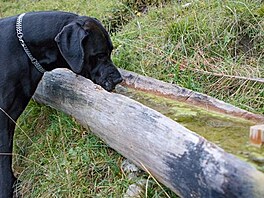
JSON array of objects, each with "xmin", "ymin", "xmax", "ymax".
[{"xmin": 113, "ymin": 0, "xmax": 264, "ymax": 114}]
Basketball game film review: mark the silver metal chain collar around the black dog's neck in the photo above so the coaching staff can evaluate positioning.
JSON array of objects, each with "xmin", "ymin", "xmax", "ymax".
[{"xmin": 16, "ymin": 13, "xmax": 46, "ymax": 73}]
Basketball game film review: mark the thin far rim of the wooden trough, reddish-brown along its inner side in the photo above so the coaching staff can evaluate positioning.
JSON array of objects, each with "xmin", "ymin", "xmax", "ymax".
[{"xmin": 119, "ymin": 69, "xmax": 264, "ymax": 123}]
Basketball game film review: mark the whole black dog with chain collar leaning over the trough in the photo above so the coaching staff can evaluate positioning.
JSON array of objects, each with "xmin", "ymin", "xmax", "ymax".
[{"xmin": 0, "ymin": 12, "xmax": 122, "ymax": 198}]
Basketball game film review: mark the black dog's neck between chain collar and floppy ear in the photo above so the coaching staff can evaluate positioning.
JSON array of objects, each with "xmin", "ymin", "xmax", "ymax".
[{"xmin": 20, "ymin": 12, "xmax": 77, "ymax": 71}]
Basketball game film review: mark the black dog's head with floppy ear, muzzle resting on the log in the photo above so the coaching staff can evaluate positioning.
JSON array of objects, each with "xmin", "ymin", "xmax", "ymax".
[{"xmin": 55, "ymin": 17, "xmax": 122, "ymax": 91}]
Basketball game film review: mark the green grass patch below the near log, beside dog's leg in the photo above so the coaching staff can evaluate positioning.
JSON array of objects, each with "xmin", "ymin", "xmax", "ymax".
[{"xmin": 14, "ymin": 101, "xmax": 177, "ymax": 197}]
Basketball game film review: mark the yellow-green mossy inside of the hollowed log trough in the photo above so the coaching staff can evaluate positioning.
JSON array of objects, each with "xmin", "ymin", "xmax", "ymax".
[{"xmin": 117, "ymin": 86, "xmax": 264, "ymax": 171}]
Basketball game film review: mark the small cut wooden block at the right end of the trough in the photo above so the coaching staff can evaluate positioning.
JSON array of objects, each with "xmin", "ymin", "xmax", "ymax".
[{"xmin": 249, "ymin": 124, "xmax": 264, "ymax": 147}]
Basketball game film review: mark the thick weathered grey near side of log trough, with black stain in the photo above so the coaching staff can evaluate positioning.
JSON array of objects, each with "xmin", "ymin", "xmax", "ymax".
[{"xmin": 34, "ymin": 69, "xmax": 264, "ymax": 198}]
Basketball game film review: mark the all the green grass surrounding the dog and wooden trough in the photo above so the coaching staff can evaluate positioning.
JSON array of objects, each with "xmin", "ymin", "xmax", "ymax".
[{"xmin": 0, "ymin": 0, "xmax": 264, "ymax": 197}]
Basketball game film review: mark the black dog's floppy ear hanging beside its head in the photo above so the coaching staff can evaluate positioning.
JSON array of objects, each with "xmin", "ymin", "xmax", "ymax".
[{"xmin": 55, "ymin": 22, "xmax": 88, "ymax": 73}]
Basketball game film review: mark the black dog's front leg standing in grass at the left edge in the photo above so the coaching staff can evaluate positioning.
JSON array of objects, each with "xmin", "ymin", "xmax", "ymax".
[{"xmin": 0, "ymin": 116, "xmax": 16, "ymax": 198}]
